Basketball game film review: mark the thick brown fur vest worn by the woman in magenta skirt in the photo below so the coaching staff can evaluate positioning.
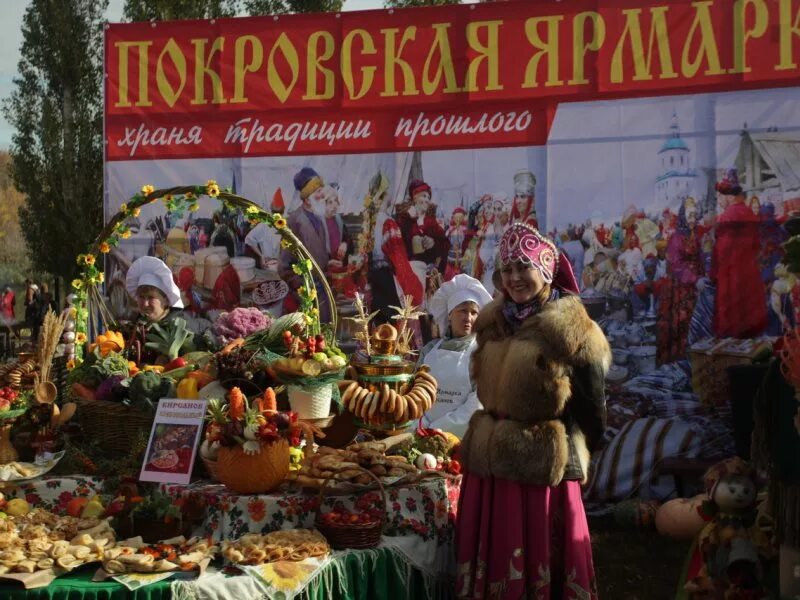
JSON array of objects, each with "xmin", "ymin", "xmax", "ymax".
[{"xmin": 462, "ymin": 296, "xmax": 611, "ymax": 486}]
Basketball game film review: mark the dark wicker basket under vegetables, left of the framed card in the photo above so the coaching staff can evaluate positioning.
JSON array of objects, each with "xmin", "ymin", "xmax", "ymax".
[{"xmin": 73, "ymin": 394, "xmax": 155, "ymax": 456}]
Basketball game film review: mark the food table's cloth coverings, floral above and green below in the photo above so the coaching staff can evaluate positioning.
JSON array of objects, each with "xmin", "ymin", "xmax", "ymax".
[{"xmin": 0, "ymin": 476, "xmax": 460, "ymax": 600}]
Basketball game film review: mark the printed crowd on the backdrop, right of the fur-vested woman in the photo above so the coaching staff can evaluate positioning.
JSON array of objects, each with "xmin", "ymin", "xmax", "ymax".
[{"xmin": 551, "ymin": 169, "xmax": 794, "ymax": 363}]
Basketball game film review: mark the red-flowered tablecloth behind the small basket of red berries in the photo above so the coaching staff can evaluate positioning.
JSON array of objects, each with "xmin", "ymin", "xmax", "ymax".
[{"xmin": 161, "ymin": 478, "xmax": 461, "ymax": 545}]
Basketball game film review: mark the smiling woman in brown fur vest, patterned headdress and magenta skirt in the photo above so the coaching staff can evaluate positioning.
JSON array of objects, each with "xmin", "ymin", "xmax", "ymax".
[{"xmin": 456, "ymin": 223, "xmax": 611, "ymax": 599}]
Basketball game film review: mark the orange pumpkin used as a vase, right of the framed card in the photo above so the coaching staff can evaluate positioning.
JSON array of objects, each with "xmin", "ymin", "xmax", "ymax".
[{"xmin": 216, "ymin": 438, "xmax": 289, "ymax": 494}]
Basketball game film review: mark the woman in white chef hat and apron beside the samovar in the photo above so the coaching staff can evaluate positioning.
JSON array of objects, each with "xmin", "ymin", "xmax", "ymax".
[{"xmin": 419, "ymin": 275, "xmax": 492, "ymax": 437}]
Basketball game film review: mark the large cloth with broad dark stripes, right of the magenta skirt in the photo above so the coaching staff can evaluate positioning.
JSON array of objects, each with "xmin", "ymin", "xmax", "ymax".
[{"xmin": 584, "ymin": 417, "xmax": 701, "ymax": 503}]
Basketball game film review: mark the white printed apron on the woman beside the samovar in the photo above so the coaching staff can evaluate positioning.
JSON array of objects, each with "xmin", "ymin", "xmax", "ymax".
[{"xmin": 422, "ymin": 340, "xmax": 477, "ymax": 428}]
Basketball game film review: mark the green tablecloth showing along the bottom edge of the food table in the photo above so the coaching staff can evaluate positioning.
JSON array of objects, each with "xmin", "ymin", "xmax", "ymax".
[{"xmin": 0, "ymin": 548, "xmax": 452, "ymax": 600}]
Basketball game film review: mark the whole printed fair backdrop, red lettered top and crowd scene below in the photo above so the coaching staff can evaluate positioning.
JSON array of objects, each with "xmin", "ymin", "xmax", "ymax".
[{"xmin": 105, "ymin": 0, "xmax": 800, "ymax": 370}]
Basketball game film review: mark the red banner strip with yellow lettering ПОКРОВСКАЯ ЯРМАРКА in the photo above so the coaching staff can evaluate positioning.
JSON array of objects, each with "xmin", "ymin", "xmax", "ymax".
[{"xmin": 105, "ymin": 0, "xmax": 800, "ymax": 160}]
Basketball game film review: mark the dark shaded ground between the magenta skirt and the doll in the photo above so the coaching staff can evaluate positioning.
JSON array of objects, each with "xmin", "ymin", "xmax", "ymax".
[{"xmin": 589, "ymin": 518, "xmax": 691, "ymax": 600}]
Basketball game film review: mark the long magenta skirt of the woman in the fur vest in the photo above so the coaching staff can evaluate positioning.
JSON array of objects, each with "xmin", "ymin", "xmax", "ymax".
[{"xmin": 456, "ymin": 474, "xmax": 597, "ymax": 600}]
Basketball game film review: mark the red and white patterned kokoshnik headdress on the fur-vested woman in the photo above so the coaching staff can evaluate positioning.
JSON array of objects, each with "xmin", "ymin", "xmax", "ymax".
[{"xmin": 500, "ymin": 223, "xmax": 580, "ymax": 294}]
